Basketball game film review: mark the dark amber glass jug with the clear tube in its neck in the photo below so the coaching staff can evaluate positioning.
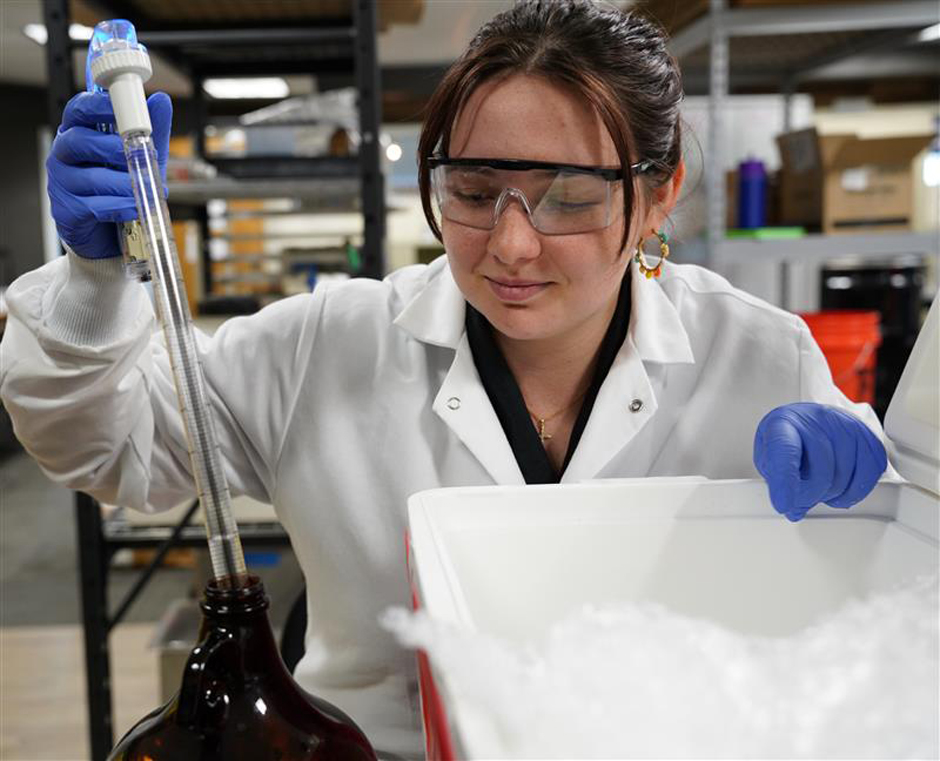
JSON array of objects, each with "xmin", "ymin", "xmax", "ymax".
[{"xmin": 109, "ymin": 576, "xmax": 375, "ymax": 761}]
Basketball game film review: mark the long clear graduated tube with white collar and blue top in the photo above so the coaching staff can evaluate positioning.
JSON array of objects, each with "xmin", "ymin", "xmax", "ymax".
[{"xmin": 88, "ymin": 19, "xmax": 246, "ymax": 587}]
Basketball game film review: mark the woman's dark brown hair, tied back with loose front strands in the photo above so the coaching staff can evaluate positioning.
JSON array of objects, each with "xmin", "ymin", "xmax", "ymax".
[{"xmin": 418, "ymin": 0, "xmax": 682, "ymax": 249}]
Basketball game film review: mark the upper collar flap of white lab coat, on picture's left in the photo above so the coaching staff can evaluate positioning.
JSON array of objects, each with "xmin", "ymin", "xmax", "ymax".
[{"xmin": 395, "ymin": 256, "xmax": 467, "ymax": 349}]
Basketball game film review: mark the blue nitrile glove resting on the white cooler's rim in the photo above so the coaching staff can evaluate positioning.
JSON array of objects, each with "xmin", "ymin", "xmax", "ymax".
[{"xmin": 754, "ymin": 402, "xmax": 888, "ymax": 521}]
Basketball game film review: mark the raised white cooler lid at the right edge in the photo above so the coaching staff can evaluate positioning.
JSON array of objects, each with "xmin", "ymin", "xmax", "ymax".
[{"xmin": 885, "ymin": 295, "xmax": 940, "ymax": 495}]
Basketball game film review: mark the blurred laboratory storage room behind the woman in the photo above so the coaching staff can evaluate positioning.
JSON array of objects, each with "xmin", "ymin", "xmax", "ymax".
[{"xmin": 0, "ymin": 0, "xmax": 940, "ymax": 761}]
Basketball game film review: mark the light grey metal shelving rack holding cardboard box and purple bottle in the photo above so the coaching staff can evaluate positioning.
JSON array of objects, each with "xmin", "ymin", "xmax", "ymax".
[{"xmin": 669, "ymin": 0, "xmax": 940, "ymax": 274}]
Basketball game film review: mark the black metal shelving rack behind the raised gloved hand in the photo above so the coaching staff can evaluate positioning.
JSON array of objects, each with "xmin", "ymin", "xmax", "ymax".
[{"xmin": 43, "ymin": 0, "xmax": 385, "ymax": 761}]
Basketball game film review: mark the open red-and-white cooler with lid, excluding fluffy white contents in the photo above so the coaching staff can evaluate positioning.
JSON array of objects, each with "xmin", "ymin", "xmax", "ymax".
[{"xmin": 409, "ymin": 301, "xmax": 940, "ymax": 759}]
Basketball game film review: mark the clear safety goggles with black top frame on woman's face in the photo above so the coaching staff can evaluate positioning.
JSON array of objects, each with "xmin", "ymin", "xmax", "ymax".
[{"xmin": 428, "ymin": 156, "xmax": 650, "ymax": 235}]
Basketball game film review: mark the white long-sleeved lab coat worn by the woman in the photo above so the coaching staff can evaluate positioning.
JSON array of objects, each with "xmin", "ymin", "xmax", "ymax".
[{"xmin": 0, "ymin": 251, "xmax": 883, "ymax": 755}]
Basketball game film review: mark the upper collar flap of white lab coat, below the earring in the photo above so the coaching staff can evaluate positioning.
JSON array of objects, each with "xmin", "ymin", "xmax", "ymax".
[{"xmin": 627, "ymin": 262, "xmax": 695, "ymax": 364}]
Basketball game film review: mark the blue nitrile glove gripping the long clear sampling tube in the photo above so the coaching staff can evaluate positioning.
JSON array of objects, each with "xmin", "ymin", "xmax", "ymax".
[{"xmin": 46, "ymin": 92, "xmax": 173, "ymax": 259}]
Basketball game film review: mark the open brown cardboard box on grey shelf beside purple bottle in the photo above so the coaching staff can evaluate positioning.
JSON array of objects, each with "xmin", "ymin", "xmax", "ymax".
[{"xmin": 777, "ymin": 129, "xmax": 933, "ymax": 233}]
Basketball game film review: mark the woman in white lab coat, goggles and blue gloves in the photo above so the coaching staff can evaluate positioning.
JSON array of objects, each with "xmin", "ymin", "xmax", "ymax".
[{"xmin": 2, "ymin": 0, "xmax": 886, "ymax": 755}]
